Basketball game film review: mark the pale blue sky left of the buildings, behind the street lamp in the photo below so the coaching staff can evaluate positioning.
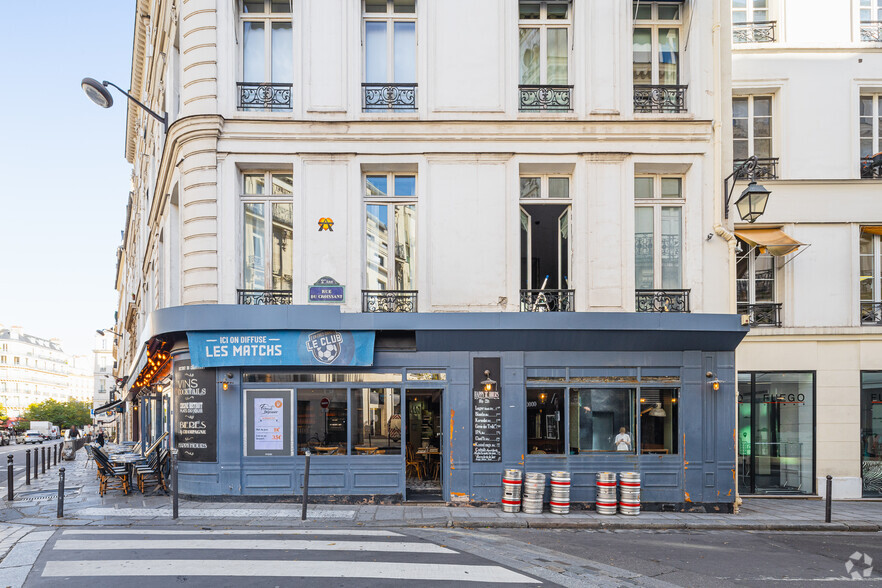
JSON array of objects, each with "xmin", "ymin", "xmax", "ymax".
[{"xmin": 0, "ymin": 0, "xmax": 135, "ymax": 353}]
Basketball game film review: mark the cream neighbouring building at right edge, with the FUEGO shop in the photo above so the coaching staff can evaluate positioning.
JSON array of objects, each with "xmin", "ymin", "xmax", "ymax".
[{"xmin": 732, "ymin": 0, "xmax": 882, "ymax": 498}]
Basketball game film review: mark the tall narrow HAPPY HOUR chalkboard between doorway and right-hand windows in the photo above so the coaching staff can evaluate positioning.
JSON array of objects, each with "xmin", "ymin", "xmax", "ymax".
[{"xmin": 472, "ymin": 357, "xmax": 502, "ymax": 463}]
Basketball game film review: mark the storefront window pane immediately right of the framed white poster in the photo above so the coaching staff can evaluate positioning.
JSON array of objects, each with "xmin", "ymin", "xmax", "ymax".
[{"xmin": 297, "ymin": 389, "xmax": 348, "ymax": 455}]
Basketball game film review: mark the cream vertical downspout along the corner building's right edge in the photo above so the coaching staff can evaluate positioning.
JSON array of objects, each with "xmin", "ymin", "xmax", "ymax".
[{"xmin": 712, "ymin": 0, "xmax": 741, "ymax": 514}]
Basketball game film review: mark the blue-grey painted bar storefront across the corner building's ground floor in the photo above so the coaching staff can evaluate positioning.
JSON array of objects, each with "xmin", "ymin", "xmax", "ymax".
[{"xmin": 132, "ymin": 305, "xmax": 747, "ymax": 510}]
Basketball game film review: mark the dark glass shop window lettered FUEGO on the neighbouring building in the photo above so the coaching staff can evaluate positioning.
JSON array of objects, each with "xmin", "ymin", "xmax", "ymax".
[{"xmin": 738, "ymin": 372, "xmax": 815, "ymax": 494}]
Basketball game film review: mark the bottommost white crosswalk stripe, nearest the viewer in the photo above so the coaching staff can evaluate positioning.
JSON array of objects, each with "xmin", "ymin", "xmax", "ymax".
[{"xmin": 43, "ymin": 559, "xmax": 540, "ymax": 584}]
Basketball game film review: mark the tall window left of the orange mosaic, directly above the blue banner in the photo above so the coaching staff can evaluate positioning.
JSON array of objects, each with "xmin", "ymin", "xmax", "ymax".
[{"xmin": 242, "ymin": 172, "xmax": 294, "ymax": 292}]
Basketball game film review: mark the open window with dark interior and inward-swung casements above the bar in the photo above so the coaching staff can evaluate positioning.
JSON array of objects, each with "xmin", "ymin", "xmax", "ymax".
[{"xmin": 520, "ymin": 175, "xmax": 573, "ymax": 311}]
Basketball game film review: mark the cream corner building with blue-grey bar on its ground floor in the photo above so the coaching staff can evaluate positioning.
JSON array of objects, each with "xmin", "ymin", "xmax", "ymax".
[{"xmin": 115, "ymin": 0, "xmax": 748, "ymax": 510}]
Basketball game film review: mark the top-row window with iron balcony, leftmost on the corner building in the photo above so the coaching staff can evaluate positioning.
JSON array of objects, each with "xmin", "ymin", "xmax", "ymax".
[{"xmin": 236, "ymin": 0, "xmax": 294, "ymax": 111}]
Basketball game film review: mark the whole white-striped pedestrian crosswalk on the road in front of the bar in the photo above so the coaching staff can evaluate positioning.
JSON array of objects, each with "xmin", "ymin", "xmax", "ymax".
[{"xmin": 31, "ymin": 527, "xmax": 542, "ymax": 588}]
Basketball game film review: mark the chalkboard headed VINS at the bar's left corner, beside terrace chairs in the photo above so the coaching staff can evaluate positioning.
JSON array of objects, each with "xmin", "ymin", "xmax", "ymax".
[{"xmin": 175, "ymin": 360, "xmax": 217, "ymax": 462}]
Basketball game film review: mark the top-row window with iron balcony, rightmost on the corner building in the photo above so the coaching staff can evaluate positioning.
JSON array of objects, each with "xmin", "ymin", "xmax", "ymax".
[{"xmin": 633, "ymin": 1, "xmax": 688, "ymax": 113}]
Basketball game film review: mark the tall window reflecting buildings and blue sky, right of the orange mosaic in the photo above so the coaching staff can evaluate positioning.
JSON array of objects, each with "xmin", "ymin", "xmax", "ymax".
[{"xmin": 365, "ymin": 174, "xmax": 416, "ymax": 290}]
